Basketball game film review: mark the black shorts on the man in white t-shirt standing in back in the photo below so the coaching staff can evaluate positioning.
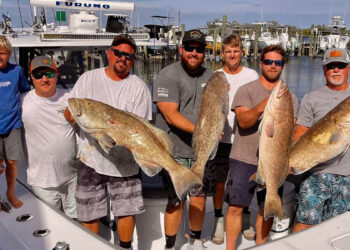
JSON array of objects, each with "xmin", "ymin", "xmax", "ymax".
[{"xmin": 214, "ymin": 142, "xmax": 232, "ymax": 183}]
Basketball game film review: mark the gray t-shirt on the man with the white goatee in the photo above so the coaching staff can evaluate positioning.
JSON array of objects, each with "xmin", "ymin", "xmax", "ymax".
[{"xmin": 297, "ymin": 85, "xmax": 350, "ymax": 176}]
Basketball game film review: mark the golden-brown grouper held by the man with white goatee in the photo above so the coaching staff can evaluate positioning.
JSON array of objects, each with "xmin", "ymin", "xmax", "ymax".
[{"xmin": 289, "ymin": 97, "xmax": 350, "ymax": 175}]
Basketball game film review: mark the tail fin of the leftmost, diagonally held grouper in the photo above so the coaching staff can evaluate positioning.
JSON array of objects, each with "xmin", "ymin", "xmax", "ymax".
[{"xmin": 168, "ymin": 163, "xmax": 202, "ymax": 200}]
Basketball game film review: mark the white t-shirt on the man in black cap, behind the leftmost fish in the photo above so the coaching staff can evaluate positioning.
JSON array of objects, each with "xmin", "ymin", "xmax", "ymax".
[{"xmin": 71, "ymin": 68, "xmax": 152, "ymax": 177}]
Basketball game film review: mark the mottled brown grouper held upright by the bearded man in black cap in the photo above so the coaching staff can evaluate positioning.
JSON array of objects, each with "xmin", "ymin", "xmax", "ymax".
[{"xmin": 191, "ymin": 71, "xmax": 230, "ymax": 180}]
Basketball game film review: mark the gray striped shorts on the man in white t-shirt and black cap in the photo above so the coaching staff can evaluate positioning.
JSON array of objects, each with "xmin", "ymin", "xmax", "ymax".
[{"xmin": 75, "ymin": 162, "xmax": 145, "ymax": 221}]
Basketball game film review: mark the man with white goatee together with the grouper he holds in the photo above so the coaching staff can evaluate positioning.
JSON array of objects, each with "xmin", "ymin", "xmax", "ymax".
[{"xmin": 290, "ymin": 48, "xmax": 350, "ymax": 232}]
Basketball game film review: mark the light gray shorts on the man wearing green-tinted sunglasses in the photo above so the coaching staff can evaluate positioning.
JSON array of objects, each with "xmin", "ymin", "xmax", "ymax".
[{"xmin": 32, "ymin": 176, "xmax": 77, "ymax": 219}]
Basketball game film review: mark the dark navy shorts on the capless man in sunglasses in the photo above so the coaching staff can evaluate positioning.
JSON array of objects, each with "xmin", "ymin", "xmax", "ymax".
[{"xmin": 224, "ymin": 159, "xmax": 283, "ymax": 210}]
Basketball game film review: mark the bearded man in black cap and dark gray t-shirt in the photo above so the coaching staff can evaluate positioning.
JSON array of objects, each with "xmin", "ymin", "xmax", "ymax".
[{"xmin": 153, "ymin": 30, "xmax": 215, "ymax": 249}]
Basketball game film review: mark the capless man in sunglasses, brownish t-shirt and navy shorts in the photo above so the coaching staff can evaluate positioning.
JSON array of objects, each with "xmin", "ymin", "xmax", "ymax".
[{"xmin": 224, "ymin": 45, "xmax": 298, "ymax": 250}]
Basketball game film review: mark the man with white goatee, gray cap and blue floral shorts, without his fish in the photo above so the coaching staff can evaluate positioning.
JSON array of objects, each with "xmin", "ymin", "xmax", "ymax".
[{"xmin": 293, "ymin": 48, "xmax": 350, "ymax": 232}]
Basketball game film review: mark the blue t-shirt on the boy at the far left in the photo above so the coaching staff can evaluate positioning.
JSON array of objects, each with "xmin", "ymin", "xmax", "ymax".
[{"xmin": 0, "ymin": 63, "xmax": 30, "ymax": 134}]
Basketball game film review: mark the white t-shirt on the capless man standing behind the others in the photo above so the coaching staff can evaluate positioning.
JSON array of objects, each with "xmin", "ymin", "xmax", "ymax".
[{"xmin": 218, "ymin": 66, "xmax": 259, "ymax": 143}]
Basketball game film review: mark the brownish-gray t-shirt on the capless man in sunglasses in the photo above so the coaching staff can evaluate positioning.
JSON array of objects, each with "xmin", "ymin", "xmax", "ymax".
[{"xmin": 230, "ymin": 79, "xmax": 298, "ymax": 165}]
